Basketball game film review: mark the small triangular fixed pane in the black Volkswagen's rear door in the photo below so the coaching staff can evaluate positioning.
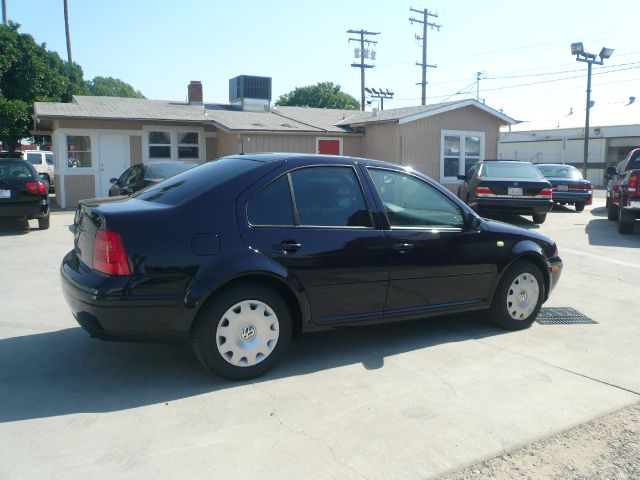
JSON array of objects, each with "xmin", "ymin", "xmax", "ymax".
[{"xmin": 247, "ymin": 175, "xmax": 294, "ymax": 226}]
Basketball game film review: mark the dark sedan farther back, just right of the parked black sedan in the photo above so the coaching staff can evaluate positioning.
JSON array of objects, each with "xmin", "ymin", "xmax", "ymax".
[{"xmin": 536, "ymin": 163, "xmax": 593, "ymax": 212}]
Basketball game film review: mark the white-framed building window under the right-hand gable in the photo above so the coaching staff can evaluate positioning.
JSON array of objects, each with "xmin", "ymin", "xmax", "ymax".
[{"xmin": 440, "ymin": 131, "xmax": 484, "ymax": 181}]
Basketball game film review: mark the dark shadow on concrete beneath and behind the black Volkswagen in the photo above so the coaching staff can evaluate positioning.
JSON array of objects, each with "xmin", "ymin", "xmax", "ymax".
[{"xmin": 0, "ymin": 314, "xmax": 506, "ymax": 423}]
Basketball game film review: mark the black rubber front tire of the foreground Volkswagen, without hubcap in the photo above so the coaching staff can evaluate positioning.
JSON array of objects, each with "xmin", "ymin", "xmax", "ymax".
[{"xmin": 489, "ymin": 260, "xmax": 545, "ymax": 330}]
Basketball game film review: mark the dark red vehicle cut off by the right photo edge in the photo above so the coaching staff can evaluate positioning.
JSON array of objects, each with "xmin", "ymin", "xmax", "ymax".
[{"xmin": 606, "ymin": 148, "xmax": 640, "ymax": 233}]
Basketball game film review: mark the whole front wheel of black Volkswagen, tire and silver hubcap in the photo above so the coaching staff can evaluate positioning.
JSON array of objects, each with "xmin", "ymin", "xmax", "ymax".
[{"xmin": 489, "ymin": 260, "xmax": 545, "ymax": 330}]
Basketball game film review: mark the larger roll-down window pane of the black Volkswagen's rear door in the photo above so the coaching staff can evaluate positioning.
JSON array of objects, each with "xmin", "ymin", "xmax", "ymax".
[{"xmin": 290, "ymin": 167, "xmax": 371, "ymax": 227}]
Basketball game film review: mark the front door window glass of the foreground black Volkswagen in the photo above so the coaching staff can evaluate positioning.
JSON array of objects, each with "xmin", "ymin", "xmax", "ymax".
[{"xmin": 369, "ymin": 168, "xmax": 464, "ymax": 228}]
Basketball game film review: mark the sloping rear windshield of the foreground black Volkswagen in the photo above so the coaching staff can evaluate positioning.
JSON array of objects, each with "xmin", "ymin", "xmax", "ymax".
[{"xmin": 132, "ymin": 157, "xmax": 264, "ymax": 205}]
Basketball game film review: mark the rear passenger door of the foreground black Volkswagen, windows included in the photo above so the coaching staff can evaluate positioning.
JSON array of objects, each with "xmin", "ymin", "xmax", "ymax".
[{"xmin": 243, "ymin": 165, "xmax": 388, "ymax": 324}]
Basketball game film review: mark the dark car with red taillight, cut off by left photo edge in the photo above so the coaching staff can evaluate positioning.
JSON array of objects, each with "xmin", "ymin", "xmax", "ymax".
[{"xmin": 0, "ymin": 158, "xmax": 49, "ymax": 230}]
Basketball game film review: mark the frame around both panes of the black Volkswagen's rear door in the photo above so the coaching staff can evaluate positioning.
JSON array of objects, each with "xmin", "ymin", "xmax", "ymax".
[{"xmin": 244, "ymin": 164, "xmax": 376, "ymax": 230}]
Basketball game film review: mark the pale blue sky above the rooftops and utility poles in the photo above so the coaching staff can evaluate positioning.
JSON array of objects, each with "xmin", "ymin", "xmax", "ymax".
[{"xmin": 6, "ymin": 0, "xmax": 640, "ymax": 124}]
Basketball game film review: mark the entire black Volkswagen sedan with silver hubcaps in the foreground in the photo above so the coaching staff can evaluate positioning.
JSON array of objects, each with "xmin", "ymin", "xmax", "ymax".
[{"xmin": 61, "ymin": 154, "xmax": 562, "ymax": 379}]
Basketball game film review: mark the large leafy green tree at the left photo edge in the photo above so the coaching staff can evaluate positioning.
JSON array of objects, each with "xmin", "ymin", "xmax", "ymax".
[{"xmin": 0, "ymin": 22, "xmax": 87, "ymax": 149}]
